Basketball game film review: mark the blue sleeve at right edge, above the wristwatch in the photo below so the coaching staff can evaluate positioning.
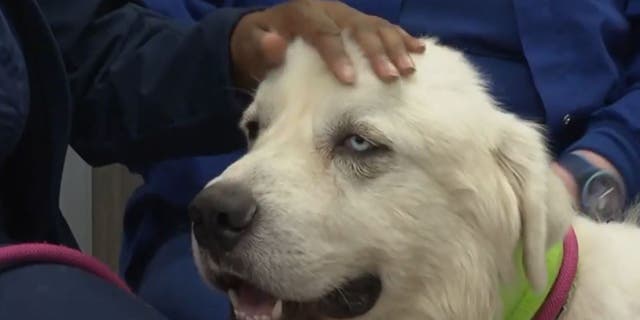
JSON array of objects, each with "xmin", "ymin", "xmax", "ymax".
[{"xmin": 566, "ymin": 0, "xmax": 640, "ymax": 200}]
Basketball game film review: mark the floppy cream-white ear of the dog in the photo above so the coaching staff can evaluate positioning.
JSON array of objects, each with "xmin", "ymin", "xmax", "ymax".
[{"xmin": 493, "ymin": 119, "xmax": 550, "ymax": 291}]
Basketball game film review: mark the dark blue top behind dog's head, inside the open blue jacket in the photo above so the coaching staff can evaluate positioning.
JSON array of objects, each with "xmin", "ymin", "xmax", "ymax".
[{"xmin": 396, "ymin": 0, "xmax": 545, "ymax": 122}]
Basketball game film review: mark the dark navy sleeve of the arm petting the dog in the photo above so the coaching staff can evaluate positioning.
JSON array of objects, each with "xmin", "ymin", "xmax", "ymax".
[{"xmin": 39, "ymin": 0, "xmax": 254, "ymax": 165}]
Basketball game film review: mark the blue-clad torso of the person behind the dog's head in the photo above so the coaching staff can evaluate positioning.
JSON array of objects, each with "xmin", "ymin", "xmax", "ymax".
[{"xmin": 210, "ymin": 0, "xmax": 632, "ymax": 153}]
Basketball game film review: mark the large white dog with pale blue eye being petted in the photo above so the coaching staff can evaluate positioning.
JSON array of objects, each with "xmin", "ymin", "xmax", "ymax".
[{"xmin": 191, "ymin": 35, "xmax": 640, "ymax": 320}]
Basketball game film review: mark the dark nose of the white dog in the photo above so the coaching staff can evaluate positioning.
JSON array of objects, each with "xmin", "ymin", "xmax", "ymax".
[{"xmin": 189, "ymin": 182, "xmax": 256, "ymax": 251}]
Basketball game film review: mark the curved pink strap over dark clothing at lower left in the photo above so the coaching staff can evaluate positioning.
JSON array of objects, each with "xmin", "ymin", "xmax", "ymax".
[{"xmin": 0, "ymin": 243, "xmax": 132, "ymax": 293}]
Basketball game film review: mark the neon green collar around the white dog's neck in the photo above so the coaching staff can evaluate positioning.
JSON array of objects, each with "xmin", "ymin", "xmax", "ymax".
[{"xmin": 501, "ymin": 241, "xmax": 563, "ymax": 320}]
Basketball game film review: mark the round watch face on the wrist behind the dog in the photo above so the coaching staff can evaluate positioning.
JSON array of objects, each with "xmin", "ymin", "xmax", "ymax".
[{"xmin": 582, "ymin": 172, "xmax": 625, "ymax": 222}]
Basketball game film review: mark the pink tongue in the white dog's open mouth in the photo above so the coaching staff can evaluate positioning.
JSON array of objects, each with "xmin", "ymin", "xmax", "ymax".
[{"xmin": 229, "ymin": 284, "xmax": 282, "ymax": 320}]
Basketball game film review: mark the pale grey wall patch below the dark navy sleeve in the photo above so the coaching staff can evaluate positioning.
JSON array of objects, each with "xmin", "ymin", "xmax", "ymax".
[{"xmin": 60, "ymin": 148, "xmax": 93, "ymax": 254}]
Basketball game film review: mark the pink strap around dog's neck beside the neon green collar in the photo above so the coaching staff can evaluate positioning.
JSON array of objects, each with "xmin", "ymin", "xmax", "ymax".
[{"xmin": 534, "ymin": 228, "xmax": 578, "ymax": 320}]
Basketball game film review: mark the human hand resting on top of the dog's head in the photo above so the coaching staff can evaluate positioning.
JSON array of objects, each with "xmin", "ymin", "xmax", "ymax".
[{"xmin": 230, "ymin": 0, "xmax": 425, "ymax": 88}]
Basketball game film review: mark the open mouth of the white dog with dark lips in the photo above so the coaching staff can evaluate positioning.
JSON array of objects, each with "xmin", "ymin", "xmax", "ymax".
[{"xmin": 215, "ymin": 274, "xmax": 382, "ymax": 320}]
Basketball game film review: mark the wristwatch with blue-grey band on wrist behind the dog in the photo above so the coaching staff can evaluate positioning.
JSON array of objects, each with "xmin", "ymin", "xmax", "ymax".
[{"xmin": 558, "ymin": 153, "xmax": 626, "ymax": 222}]
